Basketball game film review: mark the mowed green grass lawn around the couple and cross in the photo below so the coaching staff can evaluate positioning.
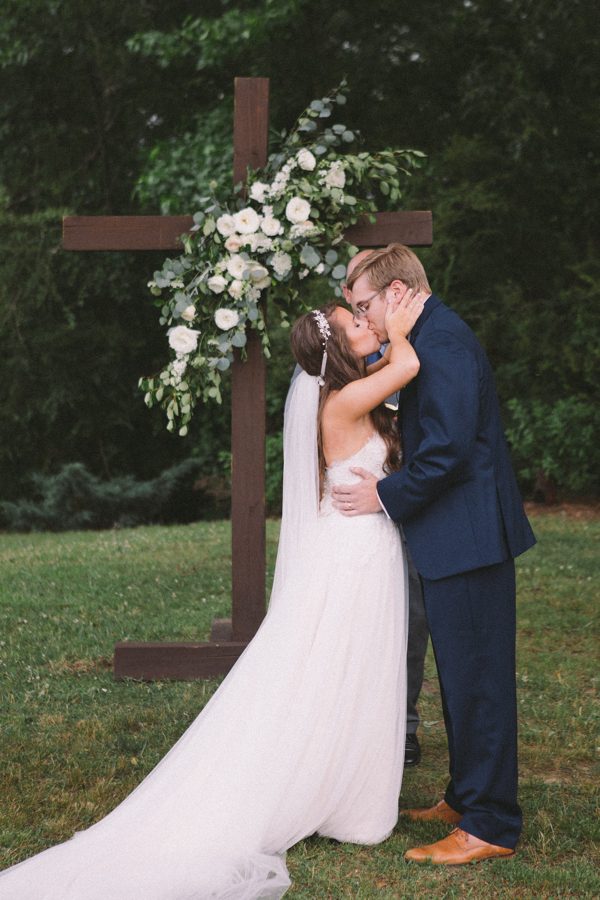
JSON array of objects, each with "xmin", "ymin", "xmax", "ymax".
[{"xmin": 0, "ymin": 513, "xmax": 600, "ymax": 900}]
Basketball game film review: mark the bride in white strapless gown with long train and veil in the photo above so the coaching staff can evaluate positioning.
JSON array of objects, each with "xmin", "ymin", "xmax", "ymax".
[{"xmin": 0, "ymin": 289, "xmax": 424, "ymax": 900}]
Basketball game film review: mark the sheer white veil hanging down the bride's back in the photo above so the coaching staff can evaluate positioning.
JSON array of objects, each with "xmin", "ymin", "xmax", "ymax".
[{"xmin": 270, "ymin": 369, "xmax": 319, "ymax": 606}]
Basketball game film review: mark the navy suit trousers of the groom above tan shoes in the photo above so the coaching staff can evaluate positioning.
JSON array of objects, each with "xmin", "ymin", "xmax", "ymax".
[{"xmin": 422, "ymin": 559, "xmax": 522, "ymax": 848}]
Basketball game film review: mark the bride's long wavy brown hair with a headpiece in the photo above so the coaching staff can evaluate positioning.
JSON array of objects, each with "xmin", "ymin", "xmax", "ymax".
[{"xmin": 290, "ymin": 303, "xmax": 400, "ymax": 493}]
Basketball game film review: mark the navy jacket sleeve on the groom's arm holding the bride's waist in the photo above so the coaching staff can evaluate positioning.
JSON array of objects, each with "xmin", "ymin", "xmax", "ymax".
[{"xmin": 377, "ymin": 331, "xmax": 479, "ymax": 522}]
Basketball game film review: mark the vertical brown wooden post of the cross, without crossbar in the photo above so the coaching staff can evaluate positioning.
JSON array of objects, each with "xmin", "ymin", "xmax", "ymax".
[{"xmin": 231, "ymin": 78, "xmax": 269, "ymax": 641}]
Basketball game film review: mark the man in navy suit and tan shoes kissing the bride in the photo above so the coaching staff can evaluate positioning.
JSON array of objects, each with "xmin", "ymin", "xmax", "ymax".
[{"xmin": 334, "ymin": 244, "xmax": 535, "ymax": 865}]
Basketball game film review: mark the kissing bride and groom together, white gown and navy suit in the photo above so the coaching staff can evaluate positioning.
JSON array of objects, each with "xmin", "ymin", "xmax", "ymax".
[{"xmin": 0, "ymin": 244, "xmax": 535, "ymax": 900}]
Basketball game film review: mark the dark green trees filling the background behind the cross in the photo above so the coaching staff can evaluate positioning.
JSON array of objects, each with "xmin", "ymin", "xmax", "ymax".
[{"xmin": 0, "ymin": 0, "xmax": 600, "ymax": 512}]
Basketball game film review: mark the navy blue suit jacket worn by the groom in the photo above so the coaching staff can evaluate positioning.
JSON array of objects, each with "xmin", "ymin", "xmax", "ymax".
[{"xmin": 377, "ymin": 294, "xmax": 535, "ymax": 580}]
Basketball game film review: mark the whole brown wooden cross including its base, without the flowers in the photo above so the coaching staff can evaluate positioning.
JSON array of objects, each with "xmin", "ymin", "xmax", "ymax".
[{"xmin": 63, "ymin": 78, "xmax": 432, "ymax": 679}]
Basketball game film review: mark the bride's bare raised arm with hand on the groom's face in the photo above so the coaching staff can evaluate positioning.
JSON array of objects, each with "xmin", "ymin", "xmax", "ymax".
[{"xmin": 328, "ymin": 291, "xmax": 429, "ymax": 419}]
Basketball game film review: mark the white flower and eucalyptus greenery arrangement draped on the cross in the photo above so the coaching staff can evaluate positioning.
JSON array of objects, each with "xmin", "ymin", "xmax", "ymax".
[{"xmin": 139, "ymin": 83, "xmax": 424, "ymax": 437}]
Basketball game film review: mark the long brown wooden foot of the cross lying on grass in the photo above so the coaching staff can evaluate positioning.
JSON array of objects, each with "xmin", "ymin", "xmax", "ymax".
[{"xmin": 114, "ymin": 641, "xmax": 248, "ymax": 681}]
